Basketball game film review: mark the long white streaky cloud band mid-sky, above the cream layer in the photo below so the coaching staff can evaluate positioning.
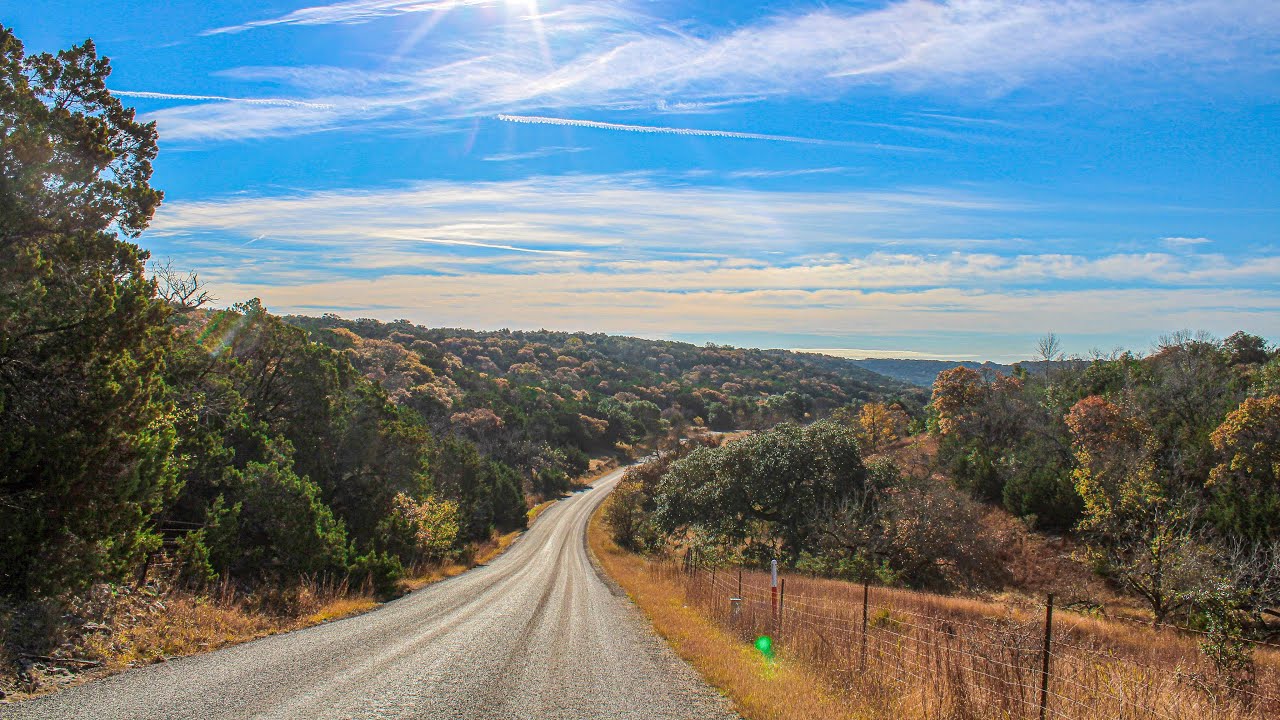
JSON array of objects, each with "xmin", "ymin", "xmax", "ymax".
[{"xmin": 140, "ymin": 174, "xmax": 1020, "ymax": 261}]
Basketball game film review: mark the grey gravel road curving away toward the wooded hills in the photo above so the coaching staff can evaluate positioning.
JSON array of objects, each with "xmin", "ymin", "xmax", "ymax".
[{"xmin": 0, "ymin": 470, "xmax": 737, "ymax": 720}]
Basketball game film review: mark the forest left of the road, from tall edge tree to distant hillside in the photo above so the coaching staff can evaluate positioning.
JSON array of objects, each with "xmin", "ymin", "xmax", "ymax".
[{"xmin": 0, "ymin": 28, "xmax": 925, "ymax": 635}]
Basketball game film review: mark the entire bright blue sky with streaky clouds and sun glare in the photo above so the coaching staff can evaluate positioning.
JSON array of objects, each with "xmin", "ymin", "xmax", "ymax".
[{"xmin": 12, "ymin": 0, "xmax": 1280, "ymax": 361}]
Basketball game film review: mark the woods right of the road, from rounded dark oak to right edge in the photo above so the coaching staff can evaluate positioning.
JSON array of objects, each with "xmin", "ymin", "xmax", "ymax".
[{"xmin": 608, "ymin": 332, "xmax": 1280, "ymax": 635}]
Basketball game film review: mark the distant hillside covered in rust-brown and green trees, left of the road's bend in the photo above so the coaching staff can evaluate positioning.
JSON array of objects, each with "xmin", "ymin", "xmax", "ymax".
[{"xmin": 285, "ymin": 314, "xmax": 927, "ymax": 453}]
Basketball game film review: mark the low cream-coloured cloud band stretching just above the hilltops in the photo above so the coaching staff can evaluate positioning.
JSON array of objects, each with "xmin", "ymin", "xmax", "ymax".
[{"xmin": 194, "ymin": 274, "xmax": 1280, "ymax": 341}]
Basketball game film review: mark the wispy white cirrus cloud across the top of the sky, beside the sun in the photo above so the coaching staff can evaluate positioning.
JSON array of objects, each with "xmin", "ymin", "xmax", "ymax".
[{"xmin": 137, "ymin": 0, "xmax": 1280, "ymax": 141}]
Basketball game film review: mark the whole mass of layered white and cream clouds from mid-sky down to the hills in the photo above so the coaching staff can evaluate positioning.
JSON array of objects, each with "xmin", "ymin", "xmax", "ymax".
[{"xmin": 143, "ymin": 174, "xmax": 1280, "ymax": 352}]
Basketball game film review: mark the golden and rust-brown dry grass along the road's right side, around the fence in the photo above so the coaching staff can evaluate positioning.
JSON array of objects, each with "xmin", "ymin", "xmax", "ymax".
[{"xmin": 591, "ymin": 491, "xmax": 1280, "ymax": 720}]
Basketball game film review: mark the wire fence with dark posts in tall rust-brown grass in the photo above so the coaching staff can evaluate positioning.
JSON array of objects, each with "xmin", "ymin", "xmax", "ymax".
[{"xmin": 675, "ymin": 552, "xmax": 1280, "ymax": 720}]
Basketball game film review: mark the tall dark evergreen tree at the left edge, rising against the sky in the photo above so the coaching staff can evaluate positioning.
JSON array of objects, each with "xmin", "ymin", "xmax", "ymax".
[{"xmin": 0, "ymin": 27, "xmax": 175, "ymax": 596}]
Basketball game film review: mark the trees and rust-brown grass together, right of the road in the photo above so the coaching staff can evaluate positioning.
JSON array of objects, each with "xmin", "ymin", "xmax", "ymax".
[{"xmin": 602, "ymin": 333, "xmax": 1280, "ymax": 717}]
